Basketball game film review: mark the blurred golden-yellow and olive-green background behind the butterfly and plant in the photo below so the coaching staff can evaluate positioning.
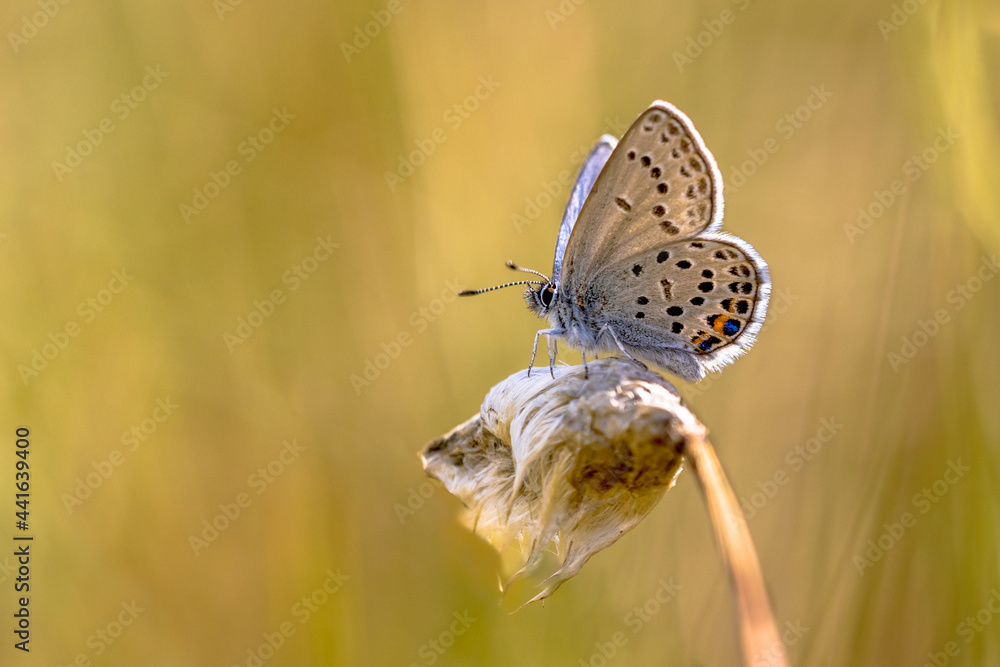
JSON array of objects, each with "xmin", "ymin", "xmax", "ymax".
[{"xmin": 0, "ymin": 0, "xmax": 1000, "ymax": 666}]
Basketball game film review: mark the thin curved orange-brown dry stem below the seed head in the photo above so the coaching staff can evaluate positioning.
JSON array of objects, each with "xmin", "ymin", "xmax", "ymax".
[{"xmin": 685, "ymin": 422, "xmax": 788, "ymax": 667}]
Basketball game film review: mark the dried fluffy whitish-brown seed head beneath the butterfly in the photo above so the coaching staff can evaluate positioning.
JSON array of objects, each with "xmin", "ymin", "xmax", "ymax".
[{"xmin": 423, "ymin": 358, "xmax": 704, "ymax": 602}]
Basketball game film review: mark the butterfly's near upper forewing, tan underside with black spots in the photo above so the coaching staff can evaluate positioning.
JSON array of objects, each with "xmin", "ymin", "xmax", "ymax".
[{"xmin": 563, "ymin": 102, "xmax": 722, "ymax": 282}]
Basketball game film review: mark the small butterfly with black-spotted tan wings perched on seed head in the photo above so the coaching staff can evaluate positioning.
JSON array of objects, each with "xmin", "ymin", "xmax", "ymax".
[{"xmin": 461, "ymin": 101, "xmax": 771, "ymax": 381}]
